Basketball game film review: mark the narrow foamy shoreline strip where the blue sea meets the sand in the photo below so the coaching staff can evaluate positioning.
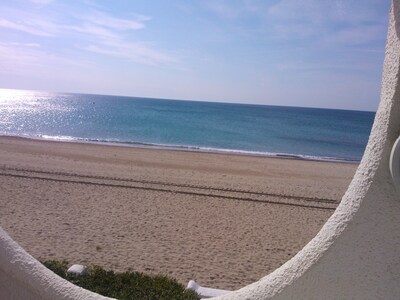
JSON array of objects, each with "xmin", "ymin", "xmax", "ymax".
[{"xmin": 0, "ymin": 135, "xmax": 361, "ymax": 165}]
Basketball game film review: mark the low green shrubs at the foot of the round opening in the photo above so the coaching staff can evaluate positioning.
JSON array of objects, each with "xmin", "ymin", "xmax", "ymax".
[{"xmin": 43, "ymin": 260, "xmax": 199, "ymax": 300}]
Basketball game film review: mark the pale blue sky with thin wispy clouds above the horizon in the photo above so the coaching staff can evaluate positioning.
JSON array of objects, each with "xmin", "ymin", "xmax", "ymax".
[{"xmin": 0, "ymin": 0, "xmax": 390, "ymax": 111}]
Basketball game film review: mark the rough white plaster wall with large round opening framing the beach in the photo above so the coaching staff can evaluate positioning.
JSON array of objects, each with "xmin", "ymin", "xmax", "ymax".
[{"xmin": 0, "ymin": 0, "xmax": 400, "ymax": 300}]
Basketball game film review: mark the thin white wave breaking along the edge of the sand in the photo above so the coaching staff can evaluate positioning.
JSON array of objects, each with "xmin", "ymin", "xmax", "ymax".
[{"xmin": 0, "ymin": 133, "xmax": 360, "ymax": 163}]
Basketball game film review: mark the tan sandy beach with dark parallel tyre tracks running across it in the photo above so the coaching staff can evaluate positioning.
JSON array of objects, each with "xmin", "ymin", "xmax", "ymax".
[{"xmin": 0, "ymin": 137, "xmax": 357, "ymax": 289}]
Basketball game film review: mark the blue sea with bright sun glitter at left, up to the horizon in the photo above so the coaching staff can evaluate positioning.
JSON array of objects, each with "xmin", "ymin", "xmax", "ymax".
[{"xmin": 0, "ymin": 89, "xmax": 375, "ymax": 162}]
